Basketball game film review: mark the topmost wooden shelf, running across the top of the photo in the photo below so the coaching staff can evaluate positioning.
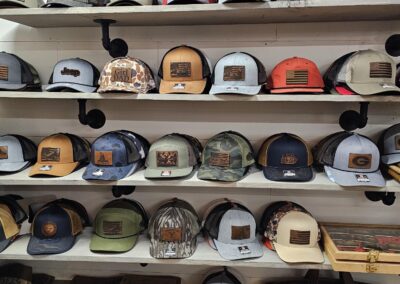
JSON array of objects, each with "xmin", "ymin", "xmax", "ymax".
[{"xmin": 0, "ymin": 0, "xmax": 400, "ymax": 28}]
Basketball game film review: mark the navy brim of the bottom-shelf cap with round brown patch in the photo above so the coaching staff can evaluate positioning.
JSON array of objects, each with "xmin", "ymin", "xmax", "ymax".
[{"xmin": 27, "ymin": 236, "xmax": 75, "ymax": 255}]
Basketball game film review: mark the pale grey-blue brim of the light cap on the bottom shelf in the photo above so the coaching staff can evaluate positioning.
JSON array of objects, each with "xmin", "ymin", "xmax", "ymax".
[{"xmin": 214, "ymin": 239, "xmax": 264, "ymax": 260}]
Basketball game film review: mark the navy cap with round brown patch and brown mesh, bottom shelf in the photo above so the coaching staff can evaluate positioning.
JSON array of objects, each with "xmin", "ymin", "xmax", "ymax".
[{"xmin": 27, "ymin": 204, "xmax": 83, "ymax": 255}]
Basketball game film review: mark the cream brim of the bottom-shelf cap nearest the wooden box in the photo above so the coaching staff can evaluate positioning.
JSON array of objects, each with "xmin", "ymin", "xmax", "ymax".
[{"xmin": 273, "ymin": 242, "xmax": 325, "ymax": 263}]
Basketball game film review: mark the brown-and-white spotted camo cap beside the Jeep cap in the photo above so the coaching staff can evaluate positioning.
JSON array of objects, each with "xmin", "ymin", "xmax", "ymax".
[{"xmin": 97, "ymin": 56, "xmax": 156, "ymax": 93}]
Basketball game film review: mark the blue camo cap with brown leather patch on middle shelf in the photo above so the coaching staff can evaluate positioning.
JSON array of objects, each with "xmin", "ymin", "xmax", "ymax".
[{"xmin": 83, "ymin": 131, "xmax": 147, "ymax": 180}]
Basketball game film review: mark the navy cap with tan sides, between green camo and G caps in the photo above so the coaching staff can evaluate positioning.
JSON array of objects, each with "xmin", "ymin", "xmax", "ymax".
[{"xmin": 258, "ymin": 133, "xmax": 313, "ymax": 181}]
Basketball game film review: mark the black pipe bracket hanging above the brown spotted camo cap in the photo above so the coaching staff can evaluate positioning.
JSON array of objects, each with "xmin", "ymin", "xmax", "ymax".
[{"xmin": 94, "ymin": 19, "xmax": 128, "ymax": 58}]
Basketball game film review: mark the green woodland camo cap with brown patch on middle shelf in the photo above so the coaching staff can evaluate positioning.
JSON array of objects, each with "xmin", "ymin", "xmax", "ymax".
[{"xmin": 197, "ymin": 132, "xmax": 255, "ymax": 182}]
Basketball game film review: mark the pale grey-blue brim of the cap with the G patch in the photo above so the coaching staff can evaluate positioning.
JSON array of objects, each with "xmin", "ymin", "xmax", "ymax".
[{"xmin": 324, "ymin": 166, "xmax": 386, "ymax": 187}]
